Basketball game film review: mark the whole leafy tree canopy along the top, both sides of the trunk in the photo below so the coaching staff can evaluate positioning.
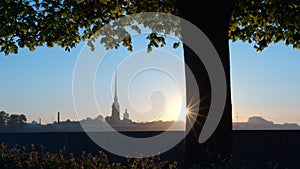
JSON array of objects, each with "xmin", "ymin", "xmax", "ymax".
[{"xmin": 0, "ymin": 0, "xmax": 300, "ymax": 55}]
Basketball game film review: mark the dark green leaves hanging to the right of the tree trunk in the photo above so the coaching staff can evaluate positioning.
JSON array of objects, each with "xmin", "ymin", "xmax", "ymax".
[{"xmin": 229, "ymin": 0, "xmax": 300, "ymax": 51}]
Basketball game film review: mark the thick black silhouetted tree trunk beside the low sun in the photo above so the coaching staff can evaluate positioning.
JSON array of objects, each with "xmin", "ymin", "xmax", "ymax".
[{"xmin": 178, "ymin": 0, "xmax": 234, "ymax": 169}]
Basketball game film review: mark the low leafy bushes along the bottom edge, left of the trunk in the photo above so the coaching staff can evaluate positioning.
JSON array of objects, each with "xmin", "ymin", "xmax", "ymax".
[{"xmin": 0, "ymin": 144, "xmax": 177, "ymax": 169}]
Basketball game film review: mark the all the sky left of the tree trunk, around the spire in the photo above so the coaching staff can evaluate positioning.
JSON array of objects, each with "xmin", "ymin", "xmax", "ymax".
[{"xmin": 0, "ymin": 35, "xmax": 185, "ymax": 123}]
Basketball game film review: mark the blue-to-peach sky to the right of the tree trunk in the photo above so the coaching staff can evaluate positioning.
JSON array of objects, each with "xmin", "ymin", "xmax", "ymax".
[{"xmin": 230, "ymin": 42, "xmax": 300, "ymax": 124}]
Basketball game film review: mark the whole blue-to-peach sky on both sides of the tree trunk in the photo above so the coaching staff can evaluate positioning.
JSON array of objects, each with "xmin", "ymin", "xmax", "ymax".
[{"xmin": 0, "ymin": 36, "xmax": 300, "ymax": 124}]
